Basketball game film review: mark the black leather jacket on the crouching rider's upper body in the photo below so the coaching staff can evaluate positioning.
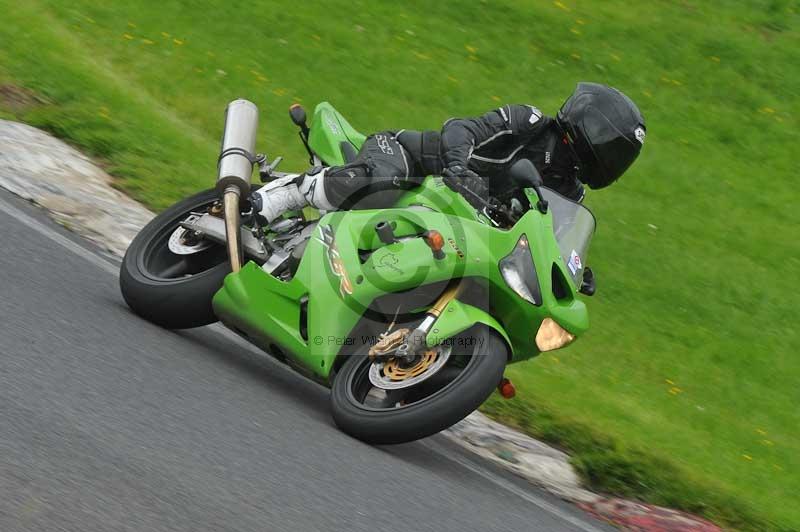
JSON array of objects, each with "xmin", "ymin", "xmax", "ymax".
[{"xmin": 439, "ymin": 105, "xmax": 584, "ymax": 201}]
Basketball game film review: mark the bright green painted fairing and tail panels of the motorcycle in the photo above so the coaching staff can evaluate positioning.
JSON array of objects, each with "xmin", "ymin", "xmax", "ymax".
[{"xmin": 213, "ymin": 104, "xmax": 589, "ymax": 382}]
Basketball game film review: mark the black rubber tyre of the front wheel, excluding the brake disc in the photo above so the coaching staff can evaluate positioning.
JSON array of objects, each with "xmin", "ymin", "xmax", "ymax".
[{"xmin": 331, "ymin": 325, "xmax": 508, "ymax": 444}]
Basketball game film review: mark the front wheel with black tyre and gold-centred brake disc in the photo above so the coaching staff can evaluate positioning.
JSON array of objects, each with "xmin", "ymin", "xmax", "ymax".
[{"xmin": 331, "ymin": 325, "xmax": 508, "ymax": 444}]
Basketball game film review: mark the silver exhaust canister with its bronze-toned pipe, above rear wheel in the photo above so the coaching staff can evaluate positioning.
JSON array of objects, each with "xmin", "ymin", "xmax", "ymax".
[{"xmin": 217, "ymin": 99, "xmax": 258, "ymax": 273}]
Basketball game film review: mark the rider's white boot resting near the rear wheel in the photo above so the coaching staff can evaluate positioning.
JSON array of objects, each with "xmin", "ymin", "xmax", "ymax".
[{"xmin": 250, "ymin": 168, "xmax": 336, "ymax": 223}]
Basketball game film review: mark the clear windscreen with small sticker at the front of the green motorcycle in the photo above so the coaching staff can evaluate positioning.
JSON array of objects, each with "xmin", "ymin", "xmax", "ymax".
[{"xmin": 542, "ymin": 187, "xmax": 597, "ymax": 287}]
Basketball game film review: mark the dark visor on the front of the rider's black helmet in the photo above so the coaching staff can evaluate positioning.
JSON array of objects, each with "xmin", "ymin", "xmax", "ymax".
[{"xmin": 581, "ymin": 107, "xmax": 642, "ymax": 189}]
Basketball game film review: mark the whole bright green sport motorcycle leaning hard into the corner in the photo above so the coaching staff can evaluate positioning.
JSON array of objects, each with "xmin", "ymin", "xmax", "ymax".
[{"xmin": 120, "ymin": 100, "xmax": 595, "ymax": 443}]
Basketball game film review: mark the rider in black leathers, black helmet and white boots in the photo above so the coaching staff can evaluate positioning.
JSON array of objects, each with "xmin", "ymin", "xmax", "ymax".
[{"xmin": 251, "ymin": 82, "xmax": 646, "ymax": 222}]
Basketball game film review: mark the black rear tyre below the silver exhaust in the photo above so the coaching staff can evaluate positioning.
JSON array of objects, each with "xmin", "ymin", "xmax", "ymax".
[{"xmin": 119, "ymin": 189, "xmax": 231, "ymax": 329}]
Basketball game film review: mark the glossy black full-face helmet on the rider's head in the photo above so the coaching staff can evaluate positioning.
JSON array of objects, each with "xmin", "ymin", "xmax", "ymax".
[{"xmin": 556, "ymin": 83, "xmax": 646, "ymax": 188}]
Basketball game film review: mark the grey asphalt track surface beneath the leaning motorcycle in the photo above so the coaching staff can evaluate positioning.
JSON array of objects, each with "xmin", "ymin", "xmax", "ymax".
[{"xmin": 0, "ymin": 191, "xmax": 613, "ymax": 532}]
